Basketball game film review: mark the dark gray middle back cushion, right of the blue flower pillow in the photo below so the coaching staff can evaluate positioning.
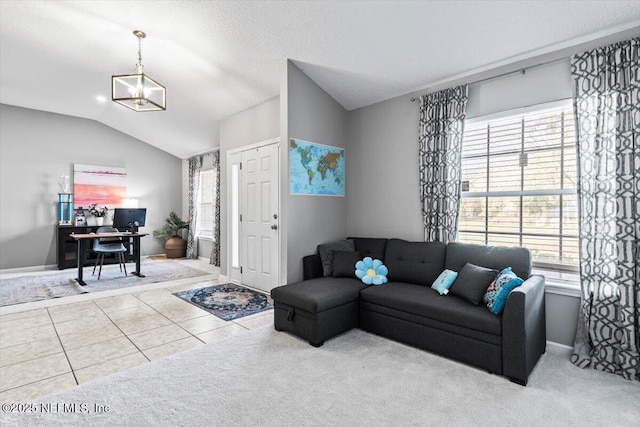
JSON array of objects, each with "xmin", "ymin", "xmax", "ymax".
[{"xmin": 384, "ymin": 239, "xmax": 444, "ymax": 286}]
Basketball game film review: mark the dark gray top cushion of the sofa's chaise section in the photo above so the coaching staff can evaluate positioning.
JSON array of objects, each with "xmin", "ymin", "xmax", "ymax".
[{"xmin": 271, "ymin": 277, "xmax": 362, "ymax": 313}]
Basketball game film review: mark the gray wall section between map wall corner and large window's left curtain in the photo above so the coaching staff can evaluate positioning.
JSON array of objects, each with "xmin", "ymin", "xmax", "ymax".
[{"xmin": 346, "ymin": 97, "xmax": 424, "ymax": 240}]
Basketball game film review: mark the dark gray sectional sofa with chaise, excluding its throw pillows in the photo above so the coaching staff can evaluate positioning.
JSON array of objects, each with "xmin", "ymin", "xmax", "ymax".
[{"xmin": 271, "ymin": 238, "xmax": 546, "ymax": 385}]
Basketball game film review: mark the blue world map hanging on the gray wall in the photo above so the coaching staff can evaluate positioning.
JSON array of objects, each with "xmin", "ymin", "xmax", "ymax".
[{"xmin": 289, "ymin": 139, "xmax": 344, "ymax": 197}]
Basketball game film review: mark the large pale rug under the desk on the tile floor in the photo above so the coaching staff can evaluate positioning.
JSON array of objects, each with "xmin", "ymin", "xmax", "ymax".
[{"xmin": 0, "ymin": 261, "xmax": 210, "ymax": 307}]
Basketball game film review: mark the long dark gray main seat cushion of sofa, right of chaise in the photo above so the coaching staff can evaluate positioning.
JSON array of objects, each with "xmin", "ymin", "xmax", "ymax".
[{"xmin": 360, "ymin": 282, "xmax": 502, "ymax": 335}]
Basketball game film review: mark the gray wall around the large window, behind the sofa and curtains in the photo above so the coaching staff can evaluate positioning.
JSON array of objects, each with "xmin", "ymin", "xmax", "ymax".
[{"xmin": 347, "ymin": 61, "xmax": 579, "ymax": 345}]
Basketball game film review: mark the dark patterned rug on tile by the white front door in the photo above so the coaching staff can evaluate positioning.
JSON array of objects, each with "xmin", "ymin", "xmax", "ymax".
[{"xmin": 173, "ymin": 283, "xmax": 273, "ymax": 320}]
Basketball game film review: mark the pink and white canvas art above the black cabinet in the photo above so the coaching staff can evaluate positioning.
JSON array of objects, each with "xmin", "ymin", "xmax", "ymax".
[{"xmin": 73, "ymin": 163, "xmax": 127, "ymax": 209}]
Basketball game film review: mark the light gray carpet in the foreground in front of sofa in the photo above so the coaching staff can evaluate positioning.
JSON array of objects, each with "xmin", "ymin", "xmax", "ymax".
[{"xmin": 1, "ymin": 327, "xmax": 640, "ymax": 427}]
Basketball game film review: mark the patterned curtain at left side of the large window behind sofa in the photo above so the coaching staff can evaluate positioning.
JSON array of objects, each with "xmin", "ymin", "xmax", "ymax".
[{"xmin": 419, "ymin": 85, "xmax": 468, "ymax": 243}]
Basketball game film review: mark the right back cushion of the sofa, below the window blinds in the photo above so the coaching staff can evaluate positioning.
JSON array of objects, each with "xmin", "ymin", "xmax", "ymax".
[{"xmin": 445, "ymin": 243, "xmax": 531, "ymax": 280}]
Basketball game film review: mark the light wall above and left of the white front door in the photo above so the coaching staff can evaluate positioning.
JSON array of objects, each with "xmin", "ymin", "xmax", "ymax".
[{"xmin": 220, "ymin": 97, "xmax": 280, "ymax": 276}]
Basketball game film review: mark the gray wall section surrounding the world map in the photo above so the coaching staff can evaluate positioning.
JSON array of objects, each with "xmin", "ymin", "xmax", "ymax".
[{"xmin": 280, "ymin": 61, "xmax": 348, "ymax": 283}]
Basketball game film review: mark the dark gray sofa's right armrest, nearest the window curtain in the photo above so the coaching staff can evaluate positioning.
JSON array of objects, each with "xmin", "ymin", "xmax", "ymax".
[{"xmin": 502, "ymin": 275, "xmax": 547, "ymax": 385}]
